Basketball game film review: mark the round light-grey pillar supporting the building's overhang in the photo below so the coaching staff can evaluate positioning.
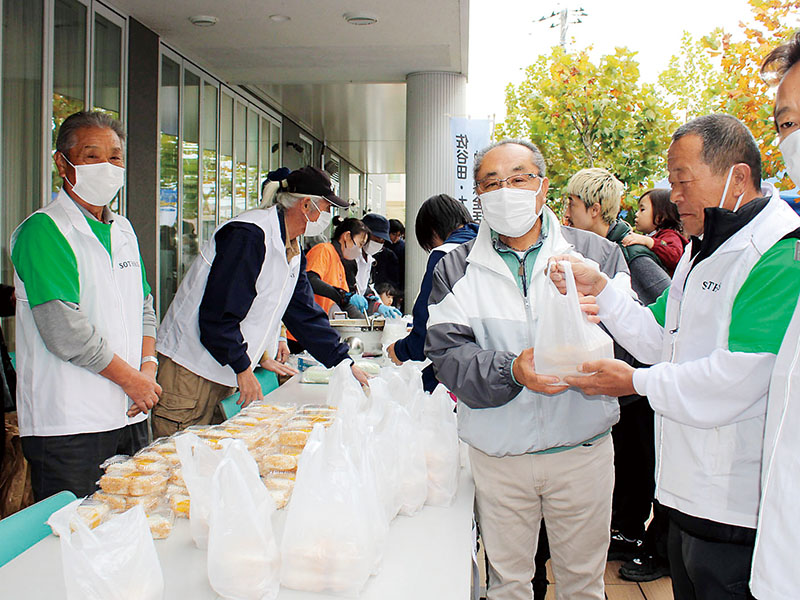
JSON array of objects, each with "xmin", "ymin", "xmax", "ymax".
[{"xmin": 405, "ymin": 71, "xmax": 467, "ymax": 304}]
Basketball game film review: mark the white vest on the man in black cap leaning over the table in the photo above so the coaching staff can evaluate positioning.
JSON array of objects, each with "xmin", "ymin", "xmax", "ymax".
[{"xmin": 157, "ymin": 206, "xmax": 300, "ymax": 387}]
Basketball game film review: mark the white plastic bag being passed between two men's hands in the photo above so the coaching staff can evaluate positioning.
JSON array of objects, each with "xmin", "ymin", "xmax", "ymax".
[{"xmin": 533, "ymin": 261, "xmax": 614, "ymax": 379}]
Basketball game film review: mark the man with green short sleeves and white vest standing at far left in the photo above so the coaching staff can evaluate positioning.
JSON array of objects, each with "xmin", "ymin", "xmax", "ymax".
[{"xmin": 11, "ymin": 112, "xmax": 161, "ymax": 500}]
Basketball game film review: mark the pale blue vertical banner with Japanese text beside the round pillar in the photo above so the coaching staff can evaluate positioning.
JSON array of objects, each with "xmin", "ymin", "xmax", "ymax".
[{"xmin": 450, "ymin": 117, "xmax": 492, "ymax": 222}]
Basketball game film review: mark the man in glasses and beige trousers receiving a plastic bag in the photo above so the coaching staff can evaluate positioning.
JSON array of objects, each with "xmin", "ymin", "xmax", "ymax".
[{"xmin": 425, "ymin": 140, "xmax": 632, "ymax": 600}]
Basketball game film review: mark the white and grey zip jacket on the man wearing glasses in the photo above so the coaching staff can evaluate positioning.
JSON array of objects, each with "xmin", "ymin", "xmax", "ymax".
[{"xmin": 425, "ymin": 208, "xmax": 633, "ymax": 457}]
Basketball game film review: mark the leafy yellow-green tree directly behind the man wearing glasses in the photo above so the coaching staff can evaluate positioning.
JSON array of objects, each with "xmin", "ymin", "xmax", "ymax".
[{"xmin": 495, "ymin": 46, "xmax": 676, "ymax": 206}]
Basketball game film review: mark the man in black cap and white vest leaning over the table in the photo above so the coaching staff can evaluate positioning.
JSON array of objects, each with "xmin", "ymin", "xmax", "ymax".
[{"xmin": 152, "ymin": 166, "xmax": 367, "ymax": 437}]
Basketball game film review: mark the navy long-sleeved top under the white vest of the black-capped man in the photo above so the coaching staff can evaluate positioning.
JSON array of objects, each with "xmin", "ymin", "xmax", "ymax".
[{"xmin": 199, "ymin": 211, "xmax": 349, "ymax": 373}]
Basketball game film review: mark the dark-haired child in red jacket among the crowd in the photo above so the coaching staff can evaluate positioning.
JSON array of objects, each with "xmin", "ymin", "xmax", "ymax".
[{"xmin": 622, "ymin": 189, "xmax": 688, "ymax": 277}]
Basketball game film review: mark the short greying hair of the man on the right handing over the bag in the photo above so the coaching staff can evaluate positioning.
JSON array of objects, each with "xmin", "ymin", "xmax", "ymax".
[{"xmin": 672, "ymin": 114, "xmax": 761, "ymax": 190}]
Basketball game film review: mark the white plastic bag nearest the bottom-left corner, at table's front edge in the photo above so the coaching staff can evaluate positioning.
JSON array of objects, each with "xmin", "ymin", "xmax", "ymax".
[{"xmin": 47, "ymin": 500, "xmax": 164, "ymax": 600}]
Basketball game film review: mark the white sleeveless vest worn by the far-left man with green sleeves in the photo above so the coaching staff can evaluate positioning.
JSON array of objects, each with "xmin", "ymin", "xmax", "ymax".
[{"xmin": 11, "ymin": 190, "xmax": 147, "ymax": 436}]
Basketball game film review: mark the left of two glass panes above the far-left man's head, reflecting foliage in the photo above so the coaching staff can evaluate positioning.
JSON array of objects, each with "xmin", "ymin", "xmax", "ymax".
[{"xmin": 50, "ymin": 0, "xmax": 87, "ymax": 197}]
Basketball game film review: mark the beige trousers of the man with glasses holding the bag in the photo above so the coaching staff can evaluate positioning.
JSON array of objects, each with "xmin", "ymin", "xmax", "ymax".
[{"xmin": 469, "ymin": 435, "xmax": 614, "ymax": 600}]
